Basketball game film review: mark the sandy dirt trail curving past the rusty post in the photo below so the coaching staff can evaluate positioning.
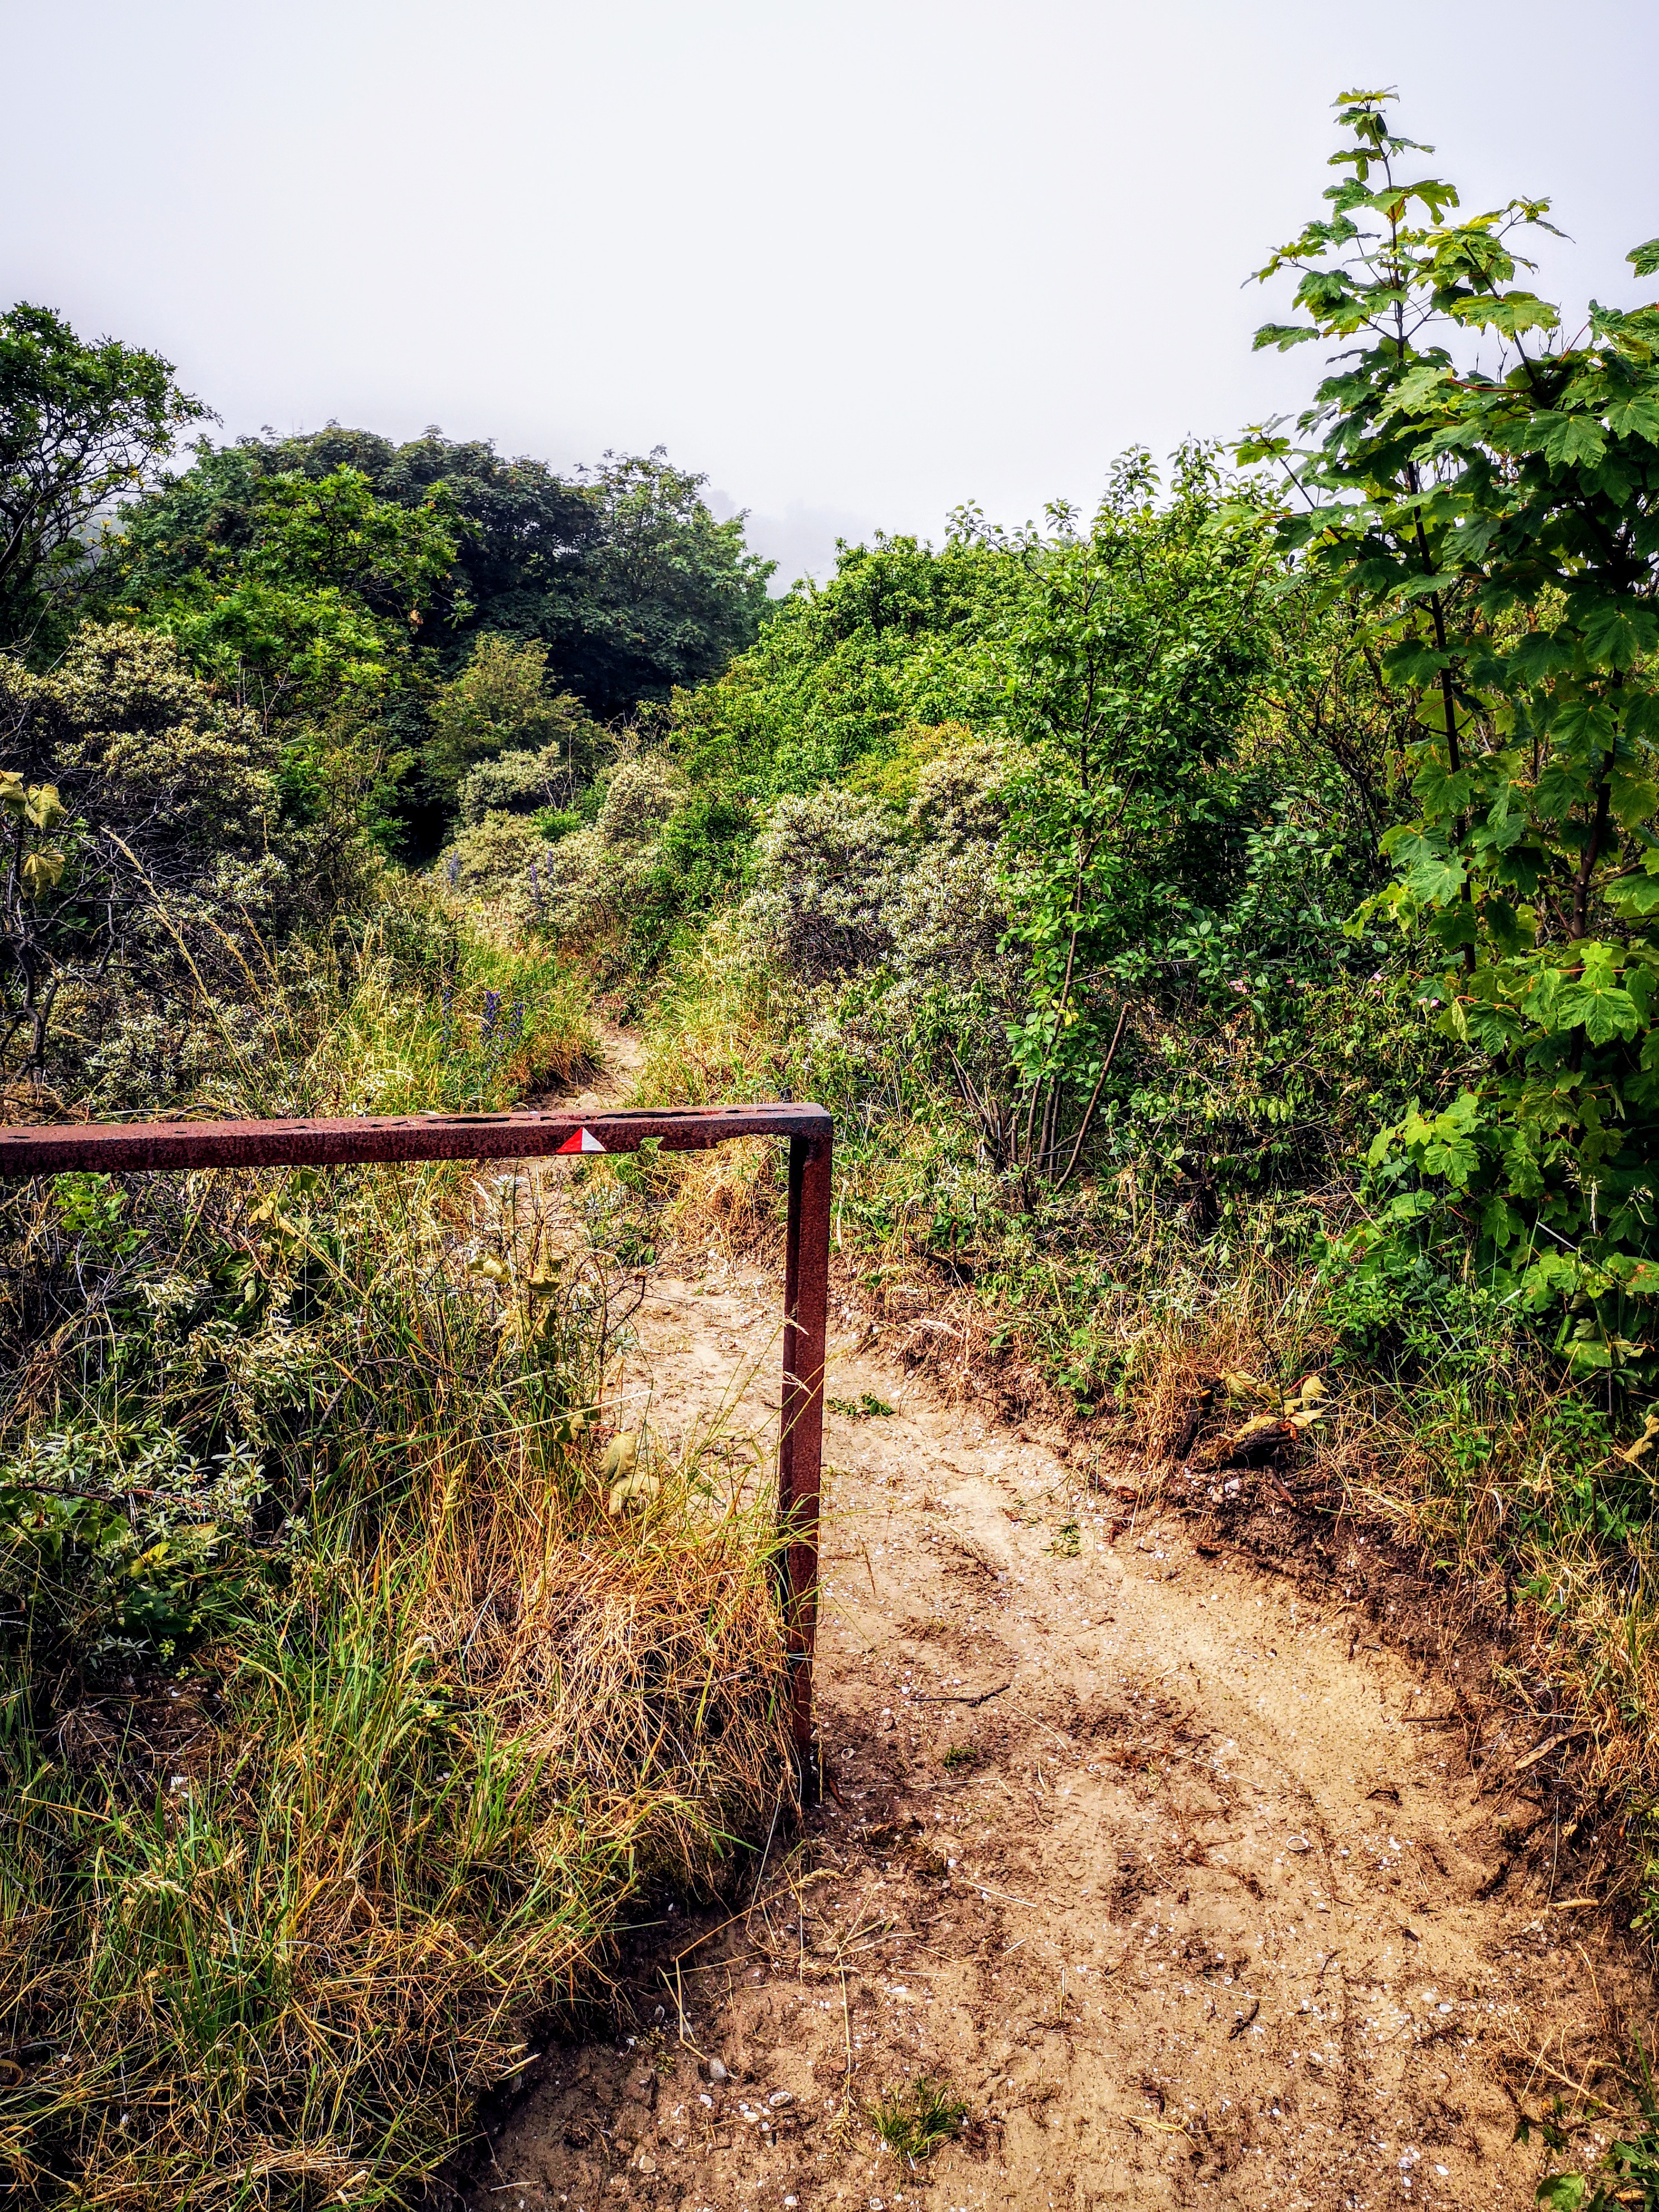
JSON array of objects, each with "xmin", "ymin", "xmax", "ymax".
[{"xmin": 469, "ymin": 1031, "xmax": 1641, "ymax": 2212}]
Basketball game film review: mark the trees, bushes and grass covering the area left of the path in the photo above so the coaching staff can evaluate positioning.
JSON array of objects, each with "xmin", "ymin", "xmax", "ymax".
[{"xmin": 0, "ymin": 323, "xmax": 783, "ymax": 2212}]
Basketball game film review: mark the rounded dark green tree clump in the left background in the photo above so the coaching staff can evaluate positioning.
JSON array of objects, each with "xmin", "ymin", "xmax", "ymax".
[{"xmin": 100, "ymin": 427, "xmax": 770, "ymax": 854}]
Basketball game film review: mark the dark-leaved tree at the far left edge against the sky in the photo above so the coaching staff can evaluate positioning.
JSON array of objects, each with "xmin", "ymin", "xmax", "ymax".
[{"xmin": 0, "ymin": 301, "xmax": 208, "ymax": 648}]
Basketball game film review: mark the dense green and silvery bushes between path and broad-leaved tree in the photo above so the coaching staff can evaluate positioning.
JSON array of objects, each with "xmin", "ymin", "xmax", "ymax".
[{"xmin": 484, "ymin": 449, "xmax": 1420, "ymax": 1214}]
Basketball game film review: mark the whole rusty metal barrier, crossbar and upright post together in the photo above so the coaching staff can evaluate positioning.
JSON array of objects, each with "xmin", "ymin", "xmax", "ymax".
[{"xmin": 0, "ymin": 1104, "xmax": 834, "ymax": 1801}]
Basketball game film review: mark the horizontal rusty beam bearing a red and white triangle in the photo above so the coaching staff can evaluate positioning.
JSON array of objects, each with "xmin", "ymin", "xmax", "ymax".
[{"xmin": 0, "ymin": 1104, "xmax": 832, "ymax": 1181}]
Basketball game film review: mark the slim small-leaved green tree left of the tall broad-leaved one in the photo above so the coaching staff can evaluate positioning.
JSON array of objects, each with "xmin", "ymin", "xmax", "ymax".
[{"xmin": 998, "ymin": 447, "xmax": 1272, "ymax": 1181}]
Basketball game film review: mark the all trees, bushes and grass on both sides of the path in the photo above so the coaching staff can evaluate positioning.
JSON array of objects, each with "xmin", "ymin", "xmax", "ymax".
[{"xmin": 0, "ymin": 77, "xmax": 1659, "ymax": 2205}]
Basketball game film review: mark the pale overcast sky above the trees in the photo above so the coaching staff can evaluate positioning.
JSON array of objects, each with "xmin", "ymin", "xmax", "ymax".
[{"xmin": 0, "ymin": 0, "xmax": 1659, "ymax": 580}]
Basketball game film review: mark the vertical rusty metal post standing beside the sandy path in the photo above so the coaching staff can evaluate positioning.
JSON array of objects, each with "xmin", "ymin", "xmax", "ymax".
[{"xmin": 779, "ymin": 1128, "xmax": 834, "ymax": 1805}]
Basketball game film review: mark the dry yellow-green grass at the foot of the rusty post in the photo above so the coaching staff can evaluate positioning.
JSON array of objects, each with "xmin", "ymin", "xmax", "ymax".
[{"xmin": 0, "ymin": 1433, "xmax": 792, "ymax": 2212}]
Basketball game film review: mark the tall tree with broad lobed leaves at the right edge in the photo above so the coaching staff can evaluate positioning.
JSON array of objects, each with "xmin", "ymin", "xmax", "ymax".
[{"xmin": 1241, "ymin": 91, "xmax": 1659, "ymax": 1367}]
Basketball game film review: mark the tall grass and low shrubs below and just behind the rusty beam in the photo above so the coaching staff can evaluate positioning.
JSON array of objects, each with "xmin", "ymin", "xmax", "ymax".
[{"xmin": 0, "ymin": 907, "xmax": 790, "ymax": 2212}]
